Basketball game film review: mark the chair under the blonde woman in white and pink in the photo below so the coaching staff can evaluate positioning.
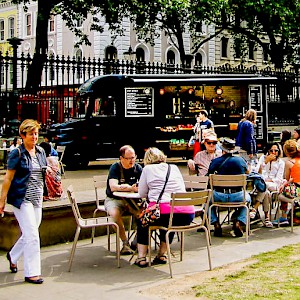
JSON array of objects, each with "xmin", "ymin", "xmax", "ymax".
[{"xmin": 148, "ymin": 190, "xmax": 212, "ymax": 278}]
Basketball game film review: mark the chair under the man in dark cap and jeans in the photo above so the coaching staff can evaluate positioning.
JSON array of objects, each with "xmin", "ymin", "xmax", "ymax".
[{"xmin": 208, "ymin": 174, "xmax": 250, "ymax": 243}]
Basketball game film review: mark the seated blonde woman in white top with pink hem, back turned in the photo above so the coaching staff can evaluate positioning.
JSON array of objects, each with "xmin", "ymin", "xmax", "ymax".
[{"xmin": 135, "ymin": 148, "xmax": 195, "ymax": 268}]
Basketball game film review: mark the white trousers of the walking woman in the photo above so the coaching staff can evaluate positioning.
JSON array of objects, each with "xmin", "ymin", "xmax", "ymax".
[{"xmin": 10, "ymin": 202, "xmax": 42, "ymax": 277}]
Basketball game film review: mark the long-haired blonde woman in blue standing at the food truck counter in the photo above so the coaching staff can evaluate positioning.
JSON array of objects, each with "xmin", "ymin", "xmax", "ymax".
[{"xmin": 236, "ymin": 109, "xmax": 257, "ymax": 161}]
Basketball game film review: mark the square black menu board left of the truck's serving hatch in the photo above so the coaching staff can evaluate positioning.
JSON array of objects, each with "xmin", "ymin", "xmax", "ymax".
[{"xmin": 125, "ymin": 87, "xmax": 154, "ymax": 117}]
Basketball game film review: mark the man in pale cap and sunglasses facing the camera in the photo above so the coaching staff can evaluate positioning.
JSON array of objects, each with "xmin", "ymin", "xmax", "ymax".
[{"xmin": 188, "ymin": 129, "xmax": 222, "ymax": 175}]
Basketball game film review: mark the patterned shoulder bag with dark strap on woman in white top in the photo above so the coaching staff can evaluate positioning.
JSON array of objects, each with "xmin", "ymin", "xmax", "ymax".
[{"xmin": 139, "ymin": 165, "xmax": 171, "ymax": 227}]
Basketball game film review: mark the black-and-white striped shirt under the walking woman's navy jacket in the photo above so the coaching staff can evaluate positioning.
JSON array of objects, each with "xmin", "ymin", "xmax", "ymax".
[{"xmin": 24, "ymin": 156, "xmax": 44, "ymax": 207}]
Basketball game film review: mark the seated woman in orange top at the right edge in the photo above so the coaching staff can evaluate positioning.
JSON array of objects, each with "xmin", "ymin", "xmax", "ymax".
[{"xmin": 273, "ymin": 140, "xmax": 300, "ymax": 225}]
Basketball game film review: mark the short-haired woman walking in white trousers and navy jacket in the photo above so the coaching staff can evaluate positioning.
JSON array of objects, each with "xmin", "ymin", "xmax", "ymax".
[{"xmin": 0, "ymin": 119, "xmax": 47, "ymax": 284}]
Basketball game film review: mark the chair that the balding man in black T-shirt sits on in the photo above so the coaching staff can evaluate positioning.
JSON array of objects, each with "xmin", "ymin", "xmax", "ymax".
[{"xmin": 92, "ymin": 175, "xmax": 133, "ymax": 245}]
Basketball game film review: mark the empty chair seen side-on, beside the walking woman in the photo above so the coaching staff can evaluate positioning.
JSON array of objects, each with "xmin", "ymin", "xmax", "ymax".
[{"xmin": 67, "ymin": 185, "xmax": 120, "ymax": 272}]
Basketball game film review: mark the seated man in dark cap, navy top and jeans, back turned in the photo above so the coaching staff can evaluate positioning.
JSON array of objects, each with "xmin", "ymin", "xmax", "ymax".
[{"xmin": 208, "ymin": 138, "xmax": 251, "ymax": 237}]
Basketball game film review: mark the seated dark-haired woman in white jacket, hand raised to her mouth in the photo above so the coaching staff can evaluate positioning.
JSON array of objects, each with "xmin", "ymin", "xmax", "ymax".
[{"xmin": 250, "ymin": 142, "xmax": 284, "ymax": 228}]
